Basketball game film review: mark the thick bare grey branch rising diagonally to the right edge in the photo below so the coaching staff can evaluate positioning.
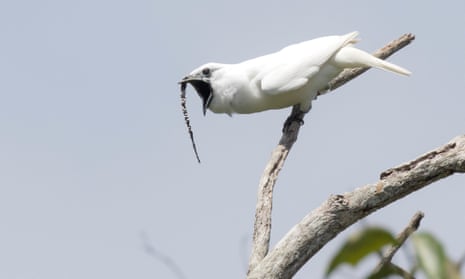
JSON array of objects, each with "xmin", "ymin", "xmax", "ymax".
[{"xmin": 247, "ymin": 135, "xmax": 465, "ymax": 279}]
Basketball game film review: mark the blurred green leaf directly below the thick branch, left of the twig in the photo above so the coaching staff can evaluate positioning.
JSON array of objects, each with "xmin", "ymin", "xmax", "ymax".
[{"xmin": 326, "ymin": 227, "xmax": 395, "ymax": 276}]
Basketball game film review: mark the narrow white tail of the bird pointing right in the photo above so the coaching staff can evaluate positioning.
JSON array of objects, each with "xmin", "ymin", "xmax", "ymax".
[{"xmin": 333, "ymin": 46, "xmax": 411, "ymax": 76}]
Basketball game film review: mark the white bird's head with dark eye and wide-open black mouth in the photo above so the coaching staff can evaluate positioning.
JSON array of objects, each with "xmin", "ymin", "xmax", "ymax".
[{"xmin": 179, "ymin": 63, "xmax": 222, "ymax": 115}]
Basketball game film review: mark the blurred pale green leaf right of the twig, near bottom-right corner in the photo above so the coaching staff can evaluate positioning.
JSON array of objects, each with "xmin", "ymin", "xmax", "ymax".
[{"xmin": 412, "ymin": 232, "xmax": 449, "ymax": 279}]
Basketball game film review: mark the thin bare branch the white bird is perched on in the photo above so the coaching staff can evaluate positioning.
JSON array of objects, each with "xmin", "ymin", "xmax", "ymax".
[{"xmin": 248, "ymin": 34, "xmax": 415, "ymax": 273}]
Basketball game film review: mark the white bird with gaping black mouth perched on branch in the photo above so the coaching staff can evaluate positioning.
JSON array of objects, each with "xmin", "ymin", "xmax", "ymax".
[{"xmin": 180, "ymin": 32, "xmax": 410, "ymax": 115}]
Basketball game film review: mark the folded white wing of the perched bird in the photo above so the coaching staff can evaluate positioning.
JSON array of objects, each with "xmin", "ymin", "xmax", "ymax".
[{"xmin": 258, "ymin": 32, "xmax": 358, "ymax": 95}]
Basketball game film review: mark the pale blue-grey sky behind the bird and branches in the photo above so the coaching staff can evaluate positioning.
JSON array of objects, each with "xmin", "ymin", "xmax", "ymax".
[{"xmin": 0, "ymin": 0, "xmax": 465, "ymax": 279}]
